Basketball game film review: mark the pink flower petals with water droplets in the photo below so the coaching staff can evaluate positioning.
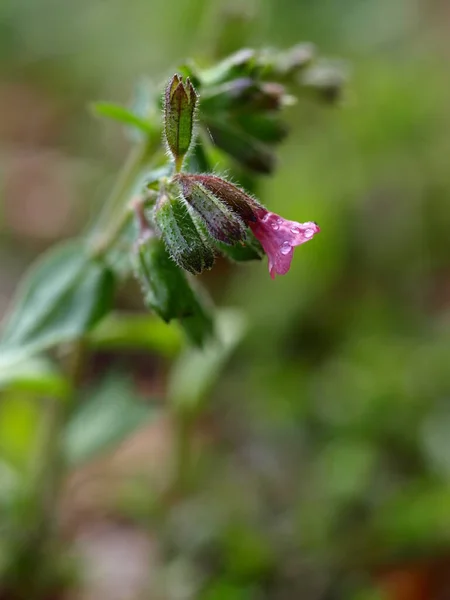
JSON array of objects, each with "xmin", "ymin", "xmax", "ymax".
[{"xmin": 248, "ymin": 208, "xmax": 320, "ymax": 279}]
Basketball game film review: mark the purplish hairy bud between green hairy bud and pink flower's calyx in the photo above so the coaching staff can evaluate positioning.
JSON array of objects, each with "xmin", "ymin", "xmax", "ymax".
[{"xmin": 176, "ymin": 173, "xmax": 246, "ymax": 245}]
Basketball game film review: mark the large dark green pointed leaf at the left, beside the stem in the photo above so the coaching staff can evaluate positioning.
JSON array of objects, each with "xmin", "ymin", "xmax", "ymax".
[{"xmin": 0, "ymin": 242, "xmax": 114, "ymax": 368}]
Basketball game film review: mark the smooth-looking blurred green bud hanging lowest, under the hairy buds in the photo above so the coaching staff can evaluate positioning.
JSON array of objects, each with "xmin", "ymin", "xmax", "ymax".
[{"xmin": 133, "ymin": 235, "xmax": 213, "ymax": 345}]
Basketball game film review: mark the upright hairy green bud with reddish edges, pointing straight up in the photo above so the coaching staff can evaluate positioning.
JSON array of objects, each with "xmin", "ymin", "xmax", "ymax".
[{"xmin": 164, "ymin": 75, "xmax": 197, "ymax": 167}]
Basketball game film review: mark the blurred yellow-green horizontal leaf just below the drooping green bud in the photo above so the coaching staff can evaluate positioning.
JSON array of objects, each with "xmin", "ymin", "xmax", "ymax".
[{"xmin": 87, "ymin": 313, "xmax": 183, "ymax": 358}]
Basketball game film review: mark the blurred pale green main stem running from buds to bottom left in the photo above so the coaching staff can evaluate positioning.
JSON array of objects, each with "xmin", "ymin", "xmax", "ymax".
[{"xmin": 10, "ymin": 132, "xmax": 164, "ymax": 600}]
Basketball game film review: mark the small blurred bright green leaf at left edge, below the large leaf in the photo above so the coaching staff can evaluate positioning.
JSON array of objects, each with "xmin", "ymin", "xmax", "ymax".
[{"xmin": 0, "ymin": 358, "xmax": 70, "ymax": 398}]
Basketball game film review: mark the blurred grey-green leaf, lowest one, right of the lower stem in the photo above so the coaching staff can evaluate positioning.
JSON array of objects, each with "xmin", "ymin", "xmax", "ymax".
[{"xmin": 63, "ymin": 374, "xmax": 155, "ymax": 465}]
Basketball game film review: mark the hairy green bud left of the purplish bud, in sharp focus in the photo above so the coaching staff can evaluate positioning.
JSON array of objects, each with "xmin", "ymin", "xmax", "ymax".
[{"xmin": 154, "ymin": 192, "xmax": 214, "ymax": 275}]
